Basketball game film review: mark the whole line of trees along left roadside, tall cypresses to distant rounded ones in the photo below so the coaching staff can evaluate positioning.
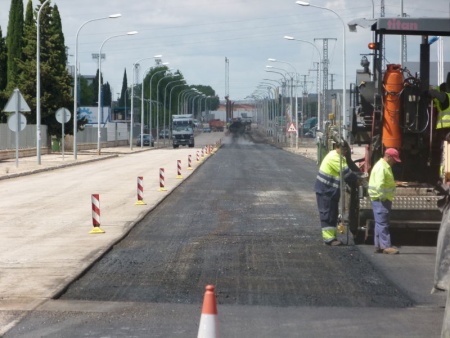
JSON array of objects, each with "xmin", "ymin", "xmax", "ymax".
[{"xmin": 0, "ymin": 0, "xmax": 219, "ymax": 143}]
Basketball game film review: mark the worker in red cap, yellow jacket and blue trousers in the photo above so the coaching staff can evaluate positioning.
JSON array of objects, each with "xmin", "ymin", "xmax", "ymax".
[{"xmin": 368, "ymin": 148, "xmax": 401, "ymax": 254}]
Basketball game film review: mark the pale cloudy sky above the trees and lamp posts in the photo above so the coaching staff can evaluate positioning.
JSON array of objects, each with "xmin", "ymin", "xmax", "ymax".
[{"xmin": 0, "ymin": 0, "xmax": 450, "ymax": 101}]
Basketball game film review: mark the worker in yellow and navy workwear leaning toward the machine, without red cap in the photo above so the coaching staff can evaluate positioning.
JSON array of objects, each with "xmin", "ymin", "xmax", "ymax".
[{"xmin": 314, "ymin": 142, "xmax": 358, "ymax": 246}]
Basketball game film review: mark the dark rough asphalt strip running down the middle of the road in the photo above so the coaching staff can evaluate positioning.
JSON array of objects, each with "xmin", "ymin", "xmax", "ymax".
[{"xmin": 61, "ymin": 132, "xmax": 413, "ymax": 308}]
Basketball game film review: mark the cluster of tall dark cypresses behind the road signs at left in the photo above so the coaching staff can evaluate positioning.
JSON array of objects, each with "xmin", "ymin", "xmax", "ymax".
[{"xmin": 0, "ymin": 0, "xmax": 92, "ymax": 136}]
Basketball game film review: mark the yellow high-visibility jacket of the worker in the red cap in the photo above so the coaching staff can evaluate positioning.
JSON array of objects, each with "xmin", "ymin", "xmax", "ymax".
[{"xmin": 368, "ymin": 158, "xmax": 395, "ymax": 201}]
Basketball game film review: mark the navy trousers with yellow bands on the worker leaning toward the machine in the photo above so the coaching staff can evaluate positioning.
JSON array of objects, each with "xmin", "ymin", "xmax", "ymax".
[{"xmin": 316, "ymin": 192, "xmax": 339, "ymax": 243}]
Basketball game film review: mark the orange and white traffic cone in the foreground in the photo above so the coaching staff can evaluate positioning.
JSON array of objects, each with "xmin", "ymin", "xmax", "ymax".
[{"xmin": 197, "ymin": 285, "xmax": 219, "ymax": 338}]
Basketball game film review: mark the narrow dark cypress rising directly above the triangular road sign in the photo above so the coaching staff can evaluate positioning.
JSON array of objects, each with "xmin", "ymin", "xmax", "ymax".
[{"xmin": 6, "ymin": 0, "xmax": 23, "ymax": 92}]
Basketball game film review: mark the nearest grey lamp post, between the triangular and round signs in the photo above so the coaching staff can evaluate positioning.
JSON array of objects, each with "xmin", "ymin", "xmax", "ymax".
[{"xmin": 36, "ymin": 0, "xmax": 50, "ymax": 164}]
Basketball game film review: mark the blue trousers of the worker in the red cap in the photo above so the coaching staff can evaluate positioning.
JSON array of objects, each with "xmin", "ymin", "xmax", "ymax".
[{"xmin": 372, "ymin": 200, "xmax": 392, "ymax": 249}]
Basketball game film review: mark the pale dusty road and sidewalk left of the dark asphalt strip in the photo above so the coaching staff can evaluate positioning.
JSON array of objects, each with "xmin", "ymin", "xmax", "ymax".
[{"xmin": 0, "ymin": 133, "xmax": 224, "ymax": 336}]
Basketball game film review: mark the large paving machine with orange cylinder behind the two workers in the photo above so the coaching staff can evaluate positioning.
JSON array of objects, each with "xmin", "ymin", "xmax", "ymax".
[{"xmin": 343, "ymin": 17, "xmax": 450, "ymax": 242}]
